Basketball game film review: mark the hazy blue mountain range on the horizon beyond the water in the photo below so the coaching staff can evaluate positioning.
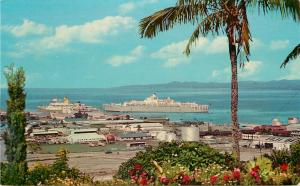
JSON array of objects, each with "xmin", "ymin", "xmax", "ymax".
[{"xmin": 106, "ymin": 80, "xmax": 300, "ymax": 91}]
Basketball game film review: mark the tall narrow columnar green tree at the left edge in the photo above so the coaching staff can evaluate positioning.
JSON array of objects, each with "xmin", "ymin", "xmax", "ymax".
[{"xmin": 1, "ymin": 66, "xmax": 27, "ymax": 185}]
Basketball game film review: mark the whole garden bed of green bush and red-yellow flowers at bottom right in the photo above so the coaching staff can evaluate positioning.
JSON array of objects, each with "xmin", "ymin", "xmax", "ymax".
[{"xmin": 115, "ymin": 142, "xmax": 300, "ymax": 185}]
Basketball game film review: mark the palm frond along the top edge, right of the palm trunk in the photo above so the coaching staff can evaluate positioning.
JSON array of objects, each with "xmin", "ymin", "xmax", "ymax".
[{"xmin": 247, "ymin": 0, "xmax": 300, "ymax": 22}]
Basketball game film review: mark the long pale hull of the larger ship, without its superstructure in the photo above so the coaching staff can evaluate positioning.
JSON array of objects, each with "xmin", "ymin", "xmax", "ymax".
[{"xmin": 104, "ymin": 105, "xmax": 208, "ymax": 113}]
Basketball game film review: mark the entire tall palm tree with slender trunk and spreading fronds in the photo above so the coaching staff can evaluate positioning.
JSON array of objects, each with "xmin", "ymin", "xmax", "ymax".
[{"xmin": 140, "ymin": 0, "xmax": 300, "ymax": 162}]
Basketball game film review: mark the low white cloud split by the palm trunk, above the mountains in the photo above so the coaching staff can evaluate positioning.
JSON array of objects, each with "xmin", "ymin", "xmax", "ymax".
[{"xmin": 211, "ymin": 61, "xmax": 262, "ymax": 81}]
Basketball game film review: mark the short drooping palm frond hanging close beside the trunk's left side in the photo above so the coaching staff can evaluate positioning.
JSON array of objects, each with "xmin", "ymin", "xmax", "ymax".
[{"xmin": 185, "ymin": 10, "xmax": 227, "ymax": 55}]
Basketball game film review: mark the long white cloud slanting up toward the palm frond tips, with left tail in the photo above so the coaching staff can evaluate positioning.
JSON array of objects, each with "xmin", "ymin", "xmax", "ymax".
[{"xmin": 7, "ymin": 16, "xmax": 136, "ymax": 58}]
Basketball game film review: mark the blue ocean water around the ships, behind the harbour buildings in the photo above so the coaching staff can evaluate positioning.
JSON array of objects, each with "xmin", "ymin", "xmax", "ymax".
[{"xmin": 0, "ymin": 88, "xmax": 300, "ymax": 124}]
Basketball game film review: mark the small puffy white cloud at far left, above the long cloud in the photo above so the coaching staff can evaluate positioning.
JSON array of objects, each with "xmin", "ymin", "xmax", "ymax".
[{"xmin": 2, "ymin": 19, "xmax": 50, "ymax": 37}]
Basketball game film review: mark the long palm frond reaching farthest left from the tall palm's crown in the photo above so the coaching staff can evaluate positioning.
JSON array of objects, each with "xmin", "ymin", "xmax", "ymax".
[{"xmin": 139, "ymin": 0, "xmax": 215, "ymax": 38}]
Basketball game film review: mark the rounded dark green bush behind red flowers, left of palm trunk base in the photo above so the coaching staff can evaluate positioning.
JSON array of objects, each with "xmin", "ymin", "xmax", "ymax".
[{"xmin": 115, "ymin": 142, "xmax": 235, "ymax": 179}]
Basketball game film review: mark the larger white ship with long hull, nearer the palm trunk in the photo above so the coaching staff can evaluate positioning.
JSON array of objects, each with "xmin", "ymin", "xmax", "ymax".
[{"xmin": 103, "ymin": 94, "xmax": 208, "ymax": 112}]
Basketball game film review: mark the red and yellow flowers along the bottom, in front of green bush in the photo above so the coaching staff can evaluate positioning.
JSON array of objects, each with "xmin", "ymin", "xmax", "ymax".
[{"xmin": 118, "ymin": 154, "xmax": 300, "ymax": 185}]
